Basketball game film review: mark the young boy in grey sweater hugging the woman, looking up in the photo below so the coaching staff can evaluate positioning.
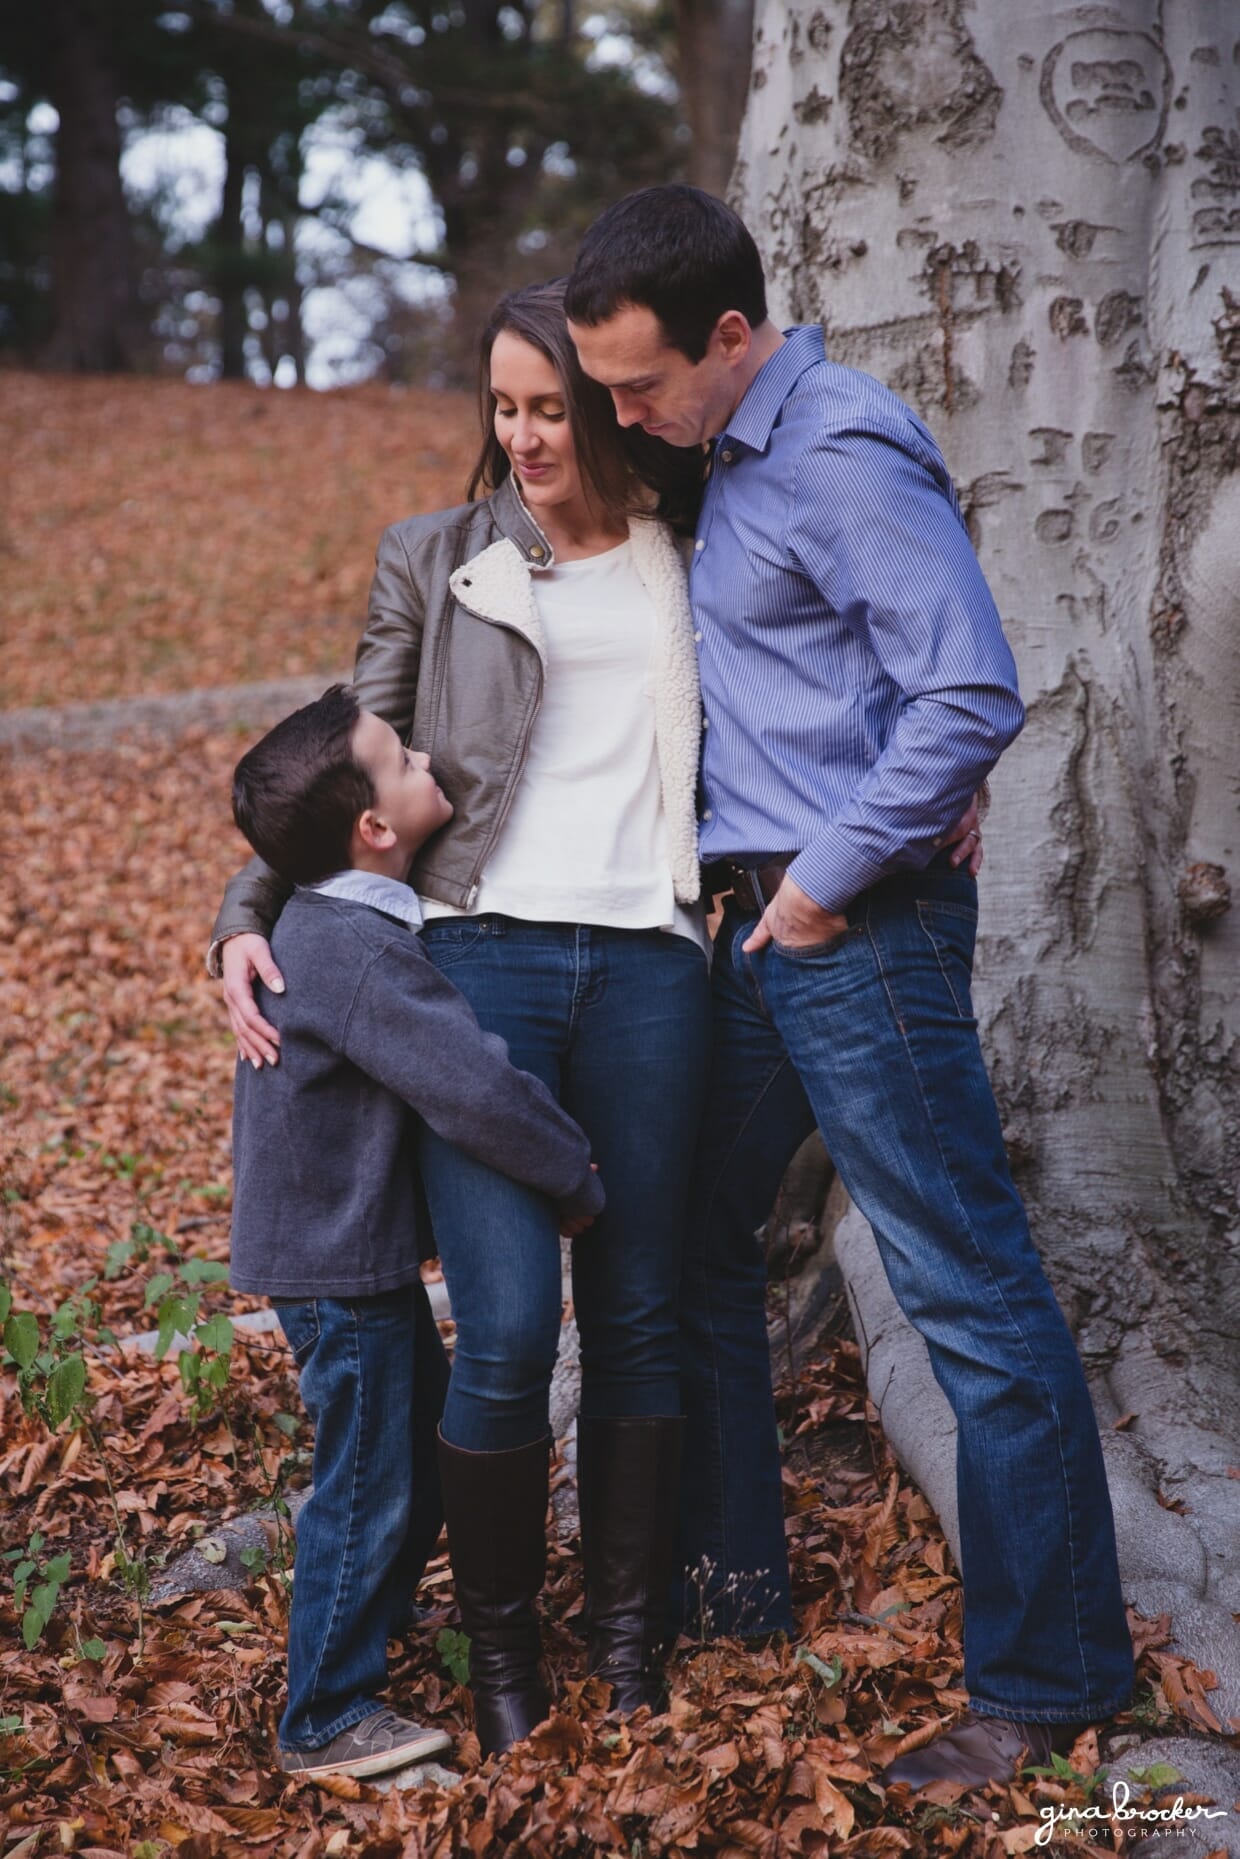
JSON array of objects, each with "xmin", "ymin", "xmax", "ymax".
[{"xmin": 231, "ymin": 684, "xmax": 602, "ymax": 1779}]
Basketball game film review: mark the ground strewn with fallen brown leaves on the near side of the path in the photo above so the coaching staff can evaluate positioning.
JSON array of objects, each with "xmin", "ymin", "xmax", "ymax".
[{"xmin": 0, "ymin": 734, "xmax": 1208, "ymax": 1859}]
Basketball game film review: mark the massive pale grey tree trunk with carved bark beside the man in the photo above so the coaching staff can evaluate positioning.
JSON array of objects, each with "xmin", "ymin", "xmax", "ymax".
[{"xmin": 732, "ymin": 0, "xmax": 1240, "ymax": 1740}]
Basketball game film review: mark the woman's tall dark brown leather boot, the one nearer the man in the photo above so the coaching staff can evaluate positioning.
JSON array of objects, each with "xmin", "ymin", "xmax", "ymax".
[{"xmin": 576, "ymin": 1415, "xmax": 684, "ymax": 1714}]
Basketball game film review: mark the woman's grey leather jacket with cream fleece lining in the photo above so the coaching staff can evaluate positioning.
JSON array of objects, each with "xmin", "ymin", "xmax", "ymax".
[{"xmin": 208, "ymin": 478, "xmax": 701, "ymax": 974}]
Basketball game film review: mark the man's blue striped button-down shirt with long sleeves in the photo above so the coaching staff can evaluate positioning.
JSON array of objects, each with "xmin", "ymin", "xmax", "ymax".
[{"xmin": 690, "ymin": 327, "xmax": 1024, "ymax": 911}]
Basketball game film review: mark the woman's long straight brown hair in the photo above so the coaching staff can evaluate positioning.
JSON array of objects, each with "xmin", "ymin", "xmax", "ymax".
[{"xmin": 467, "ymin": 277, "xmax": 706, "ymax": 532}]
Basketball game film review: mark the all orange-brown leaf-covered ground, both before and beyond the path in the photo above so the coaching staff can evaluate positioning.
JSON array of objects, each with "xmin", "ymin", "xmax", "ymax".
[{"xmin": 0, "ymin": 377, "xmax": 1234, "ymax": 1859}]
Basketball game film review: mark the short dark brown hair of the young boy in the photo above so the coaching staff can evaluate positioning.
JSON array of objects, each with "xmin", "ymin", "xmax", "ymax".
[{"xmin": 232, "ymin": 684, "xmax": 376, "ymax": 885}]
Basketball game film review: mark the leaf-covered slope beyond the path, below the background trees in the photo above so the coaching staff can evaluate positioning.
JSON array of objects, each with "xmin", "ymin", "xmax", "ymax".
[{"xmin": 0, "ymin": 374, "xmax": 476, "ymax": 708}]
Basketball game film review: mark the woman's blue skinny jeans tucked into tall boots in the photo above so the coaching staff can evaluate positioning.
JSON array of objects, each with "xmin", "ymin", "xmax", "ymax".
[{"xmin": 420, "ymin": 915, "xmax": 710, "ymax": 1452}]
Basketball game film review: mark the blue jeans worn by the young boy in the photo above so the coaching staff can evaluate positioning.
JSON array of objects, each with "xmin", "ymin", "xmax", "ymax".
[{"xmin": 275, "ymin": 1281, "xmax": 448, "ymax": 1749}]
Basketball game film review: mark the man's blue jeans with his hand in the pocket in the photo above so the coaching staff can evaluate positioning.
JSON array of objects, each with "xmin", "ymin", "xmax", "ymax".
[{"xmin": 682, "ymin": 868, "xmax": 1132, "ymax": 1723}]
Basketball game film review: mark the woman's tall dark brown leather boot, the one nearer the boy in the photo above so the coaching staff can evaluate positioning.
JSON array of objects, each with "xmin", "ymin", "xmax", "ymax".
[{"xmin": 439, "ymin": 1433, "xmax": 550, "ymax": 1755}]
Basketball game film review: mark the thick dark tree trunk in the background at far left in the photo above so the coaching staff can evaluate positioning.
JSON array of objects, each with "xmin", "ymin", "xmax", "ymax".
[{"xmin": 43, "ymin": 0, "xmax": 143, "ymax": 372}]
